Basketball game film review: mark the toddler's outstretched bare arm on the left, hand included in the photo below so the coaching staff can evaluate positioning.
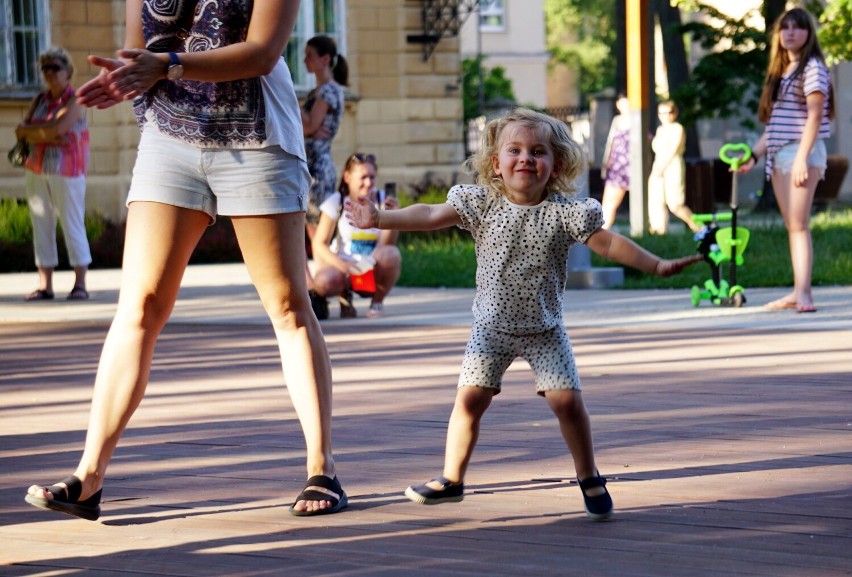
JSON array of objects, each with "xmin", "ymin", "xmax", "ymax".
[{"xmin": 343, "ymin": 198, "xmax": 461, "ymax": 230}]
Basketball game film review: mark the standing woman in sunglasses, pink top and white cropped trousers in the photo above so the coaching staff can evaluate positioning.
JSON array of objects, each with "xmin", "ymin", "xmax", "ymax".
[{"xmin": 15, "ymin": 47, "xmax": 92, "ymax": 301}]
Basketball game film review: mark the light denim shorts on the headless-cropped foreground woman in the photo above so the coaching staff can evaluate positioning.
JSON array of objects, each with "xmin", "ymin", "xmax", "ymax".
[{"xmin": 127, "ymin": 124, "xmax": 311, "ymax": 221}]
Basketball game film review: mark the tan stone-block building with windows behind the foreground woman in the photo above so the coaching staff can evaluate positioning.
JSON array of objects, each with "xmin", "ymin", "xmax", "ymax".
[{"xmin": 0, "ymin": 0, "xmax": 464, "ymax": 221}]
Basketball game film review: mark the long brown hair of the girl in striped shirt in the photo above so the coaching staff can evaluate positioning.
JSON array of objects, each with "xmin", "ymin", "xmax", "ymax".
[{"xmin": 757, "ymin": 8, "xmax": 834, "ymax": 124}]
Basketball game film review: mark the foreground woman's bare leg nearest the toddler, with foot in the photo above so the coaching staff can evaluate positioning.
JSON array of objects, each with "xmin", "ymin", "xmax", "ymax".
[{"xmin": 233, "ymin": 212, "xmax": 339, "ymax": 511}]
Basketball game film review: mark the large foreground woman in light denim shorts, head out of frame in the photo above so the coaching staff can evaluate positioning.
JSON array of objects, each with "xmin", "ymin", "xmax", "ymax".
[{"xmin": 25, "ymin": 0, "xmax": 347, "ymax": 520}]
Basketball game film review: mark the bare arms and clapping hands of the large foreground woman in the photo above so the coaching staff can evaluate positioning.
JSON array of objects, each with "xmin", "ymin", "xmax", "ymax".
[{"xmin": 78, "ymin": 0, "xmax": 299, "ymax": 108}]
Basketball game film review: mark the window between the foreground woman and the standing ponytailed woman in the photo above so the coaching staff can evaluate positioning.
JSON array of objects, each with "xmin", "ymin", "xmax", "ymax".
[{"xmin": 284, "ymin": 0, "xmax": 346, "ymax": 90}]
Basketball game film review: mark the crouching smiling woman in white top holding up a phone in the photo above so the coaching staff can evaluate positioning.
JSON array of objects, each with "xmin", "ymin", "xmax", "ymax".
[{"xmin": 311, "ymin": 154, "xmax": 402, "ymax": 318}]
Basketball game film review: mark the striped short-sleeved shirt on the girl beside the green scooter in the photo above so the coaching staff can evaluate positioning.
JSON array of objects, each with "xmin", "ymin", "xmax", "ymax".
[{"xmin": 766, "ymin": 57, "xmax": 831, "ymax": 180}]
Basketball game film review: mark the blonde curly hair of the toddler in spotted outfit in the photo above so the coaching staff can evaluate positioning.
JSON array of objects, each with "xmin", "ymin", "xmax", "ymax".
[{"xmin": 465, "ymin": 107, "xmax": 588, "ymax": 196}]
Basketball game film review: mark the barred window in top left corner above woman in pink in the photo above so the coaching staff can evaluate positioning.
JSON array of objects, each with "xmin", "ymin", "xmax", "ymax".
[{"xmin": 0, "ymin": 0, "xmax": 48, "ymax": 91}]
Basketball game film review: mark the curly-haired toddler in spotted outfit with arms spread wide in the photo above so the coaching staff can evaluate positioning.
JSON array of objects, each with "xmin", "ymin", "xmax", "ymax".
[{"xmin": 346, "ymin": 108, "xmax": 702, "ymax": 520}]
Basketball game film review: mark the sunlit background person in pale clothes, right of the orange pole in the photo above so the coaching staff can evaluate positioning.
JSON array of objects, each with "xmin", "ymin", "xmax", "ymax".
[{"xmin": 648, "ymin": 100, "xmax": 701, "ymax": 234}]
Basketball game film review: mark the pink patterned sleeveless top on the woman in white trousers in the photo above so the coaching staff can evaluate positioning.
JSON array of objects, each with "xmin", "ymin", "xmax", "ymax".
[{"xmin": 26, "ymin": 86, "xmax": 89, "ymax": 176}]
